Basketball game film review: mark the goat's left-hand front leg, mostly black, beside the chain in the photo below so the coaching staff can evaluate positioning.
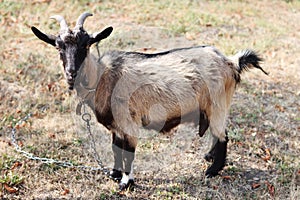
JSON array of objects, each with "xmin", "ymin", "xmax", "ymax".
[{"xmin": 109, "ymin": 132, "xmax": 124, "ymax": 181}]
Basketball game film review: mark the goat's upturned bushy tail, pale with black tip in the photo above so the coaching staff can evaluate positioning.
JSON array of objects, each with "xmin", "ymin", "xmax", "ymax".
[{"xmin": 231, "ymin": 49, "xmax": 268, "ymax": 81}]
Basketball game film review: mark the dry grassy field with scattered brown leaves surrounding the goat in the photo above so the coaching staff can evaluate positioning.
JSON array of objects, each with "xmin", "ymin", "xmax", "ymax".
[{"xmin": 0, "ymin": 0, "xmax": 300, "ymax": 200}]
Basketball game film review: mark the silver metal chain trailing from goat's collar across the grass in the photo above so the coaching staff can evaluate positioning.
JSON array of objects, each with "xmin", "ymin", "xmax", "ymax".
[{"xmin": 11, "ymin": 109, "xmax": 108, "ymax": 175}]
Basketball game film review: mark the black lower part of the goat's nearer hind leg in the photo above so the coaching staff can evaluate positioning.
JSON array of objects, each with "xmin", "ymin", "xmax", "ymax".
[{"xmin": 205, "ymin": 137, "xmax": 228, "ymax": 177}]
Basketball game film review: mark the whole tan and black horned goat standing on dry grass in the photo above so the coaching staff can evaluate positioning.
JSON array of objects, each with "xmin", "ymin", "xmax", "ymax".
[{"xmin": 31, "ymin": 12, "xmax": 267, "ymax": 190}]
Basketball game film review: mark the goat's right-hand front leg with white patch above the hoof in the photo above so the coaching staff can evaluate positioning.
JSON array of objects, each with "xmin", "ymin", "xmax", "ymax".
[{"xmin": 119, "ymin": 134, "xmax": 137, "ymax": 190}]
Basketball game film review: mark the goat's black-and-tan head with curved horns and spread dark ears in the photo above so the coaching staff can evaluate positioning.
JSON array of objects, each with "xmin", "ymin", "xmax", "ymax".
[{"xmin": 31, "ymin": 12, "xmax": 113, "ymax": 89}]
